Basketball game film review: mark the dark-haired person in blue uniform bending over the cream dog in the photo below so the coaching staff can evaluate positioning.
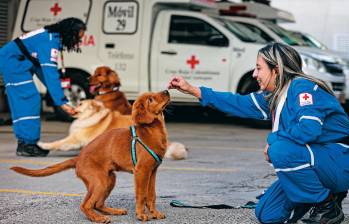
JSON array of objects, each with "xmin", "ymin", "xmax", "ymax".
[{"xmin": 0, "ymin": 18, "xmax": 86, "ymax": 156}]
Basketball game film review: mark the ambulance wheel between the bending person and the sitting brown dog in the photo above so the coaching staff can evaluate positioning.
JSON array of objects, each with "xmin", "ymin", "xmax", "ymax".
[{"xmin": 54, "ymin": 72, "xmax": 91, "ymax": 122}]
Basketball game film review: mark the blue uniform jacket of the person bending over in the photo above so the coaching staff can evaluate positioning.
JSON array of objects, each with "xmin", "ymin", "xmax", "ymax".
[{"xmin": 0, "ymin": 29, "xmax": 67, "ymax": 106}]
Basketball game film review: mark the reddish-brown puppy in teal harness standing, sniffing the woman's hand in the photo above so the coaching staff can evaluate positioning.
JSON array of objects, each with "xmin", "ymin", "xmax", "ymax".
[{"xmin": 11, "ymin": 91, "xmax": 170, "ymax": 223}]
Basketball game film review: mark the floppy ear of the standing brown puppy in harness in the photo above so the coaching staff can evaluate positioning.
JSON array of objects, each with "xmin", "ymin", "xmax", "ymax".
[{"xmin": 132, "ymin": 100, "xmax": 155, "ymax": 124}]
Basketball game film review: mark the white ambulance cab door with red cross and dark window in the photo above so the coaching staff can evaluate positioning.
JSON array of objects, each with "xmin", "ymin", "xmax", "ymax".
[{"xmin": 151, "ymin": 10, "xmax": 232, "ymax": 101}]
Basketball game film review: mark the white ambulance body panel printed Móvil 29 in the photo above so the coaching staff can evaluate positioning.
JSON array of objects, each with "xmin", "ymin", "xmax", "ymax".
[{"xmin": 98, "ymin": 0, "xmax": 143, "ymax": 96}]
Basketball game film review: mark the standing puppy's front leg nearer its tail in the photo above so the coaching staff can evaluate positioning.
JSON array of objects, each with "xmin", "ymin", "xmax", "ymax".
[{"xmin": 134, "ymin": 166, "xmax": 151, "ymax": 221}]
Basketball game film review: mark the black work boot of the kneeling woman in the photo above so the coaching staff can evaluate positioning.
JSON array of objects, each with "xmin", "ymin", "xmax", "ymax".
[{"xmin": 302, "ymin": 198, "xmax": 344, "ymax": 224}]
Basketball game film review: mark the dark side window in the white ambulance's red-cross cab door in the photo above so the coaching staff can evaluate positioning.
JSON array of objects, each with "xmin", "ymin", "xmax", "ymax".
[{"xmin": 168, "ymin": 16, "xmax": 229, "ymax": 46}]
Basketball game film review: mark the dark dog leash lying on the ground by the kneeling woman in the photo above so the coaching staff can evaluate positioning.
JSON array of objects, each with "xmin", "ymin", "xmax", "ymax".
[{"xmin": 170, "ymin": 200, "xmax": 257, "ymax": 209}]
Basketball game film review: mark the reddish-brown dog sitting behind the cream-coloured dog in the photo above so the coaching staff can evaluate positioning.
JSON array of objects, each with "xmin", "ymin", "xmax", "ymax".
[{"xmin": 90, "ymin": 66, "xmax": 132, "ymax": 114}]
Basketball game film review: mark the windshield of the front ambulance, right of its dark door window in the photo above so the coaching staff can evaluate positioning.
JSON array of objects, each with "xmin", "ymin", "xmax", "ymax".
[{"xmin": 214, "ymin": 18, "xmax": 273, "ymax": 44}]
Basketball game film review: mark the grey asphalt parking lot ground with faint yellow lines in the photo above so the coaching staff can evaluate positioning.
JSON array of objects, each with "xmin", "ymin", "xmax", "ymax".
[{"xmin": 0, "ymin": 119, "xmax": 349, "ymax": 224}]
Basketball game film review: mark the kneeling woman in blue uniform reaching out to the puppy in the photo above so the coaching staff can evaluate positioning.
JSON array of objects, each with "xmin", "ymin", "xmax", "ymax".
[{"xmin": 168, "ymin": 43, "xmax": 349, "ymax": 224}]
